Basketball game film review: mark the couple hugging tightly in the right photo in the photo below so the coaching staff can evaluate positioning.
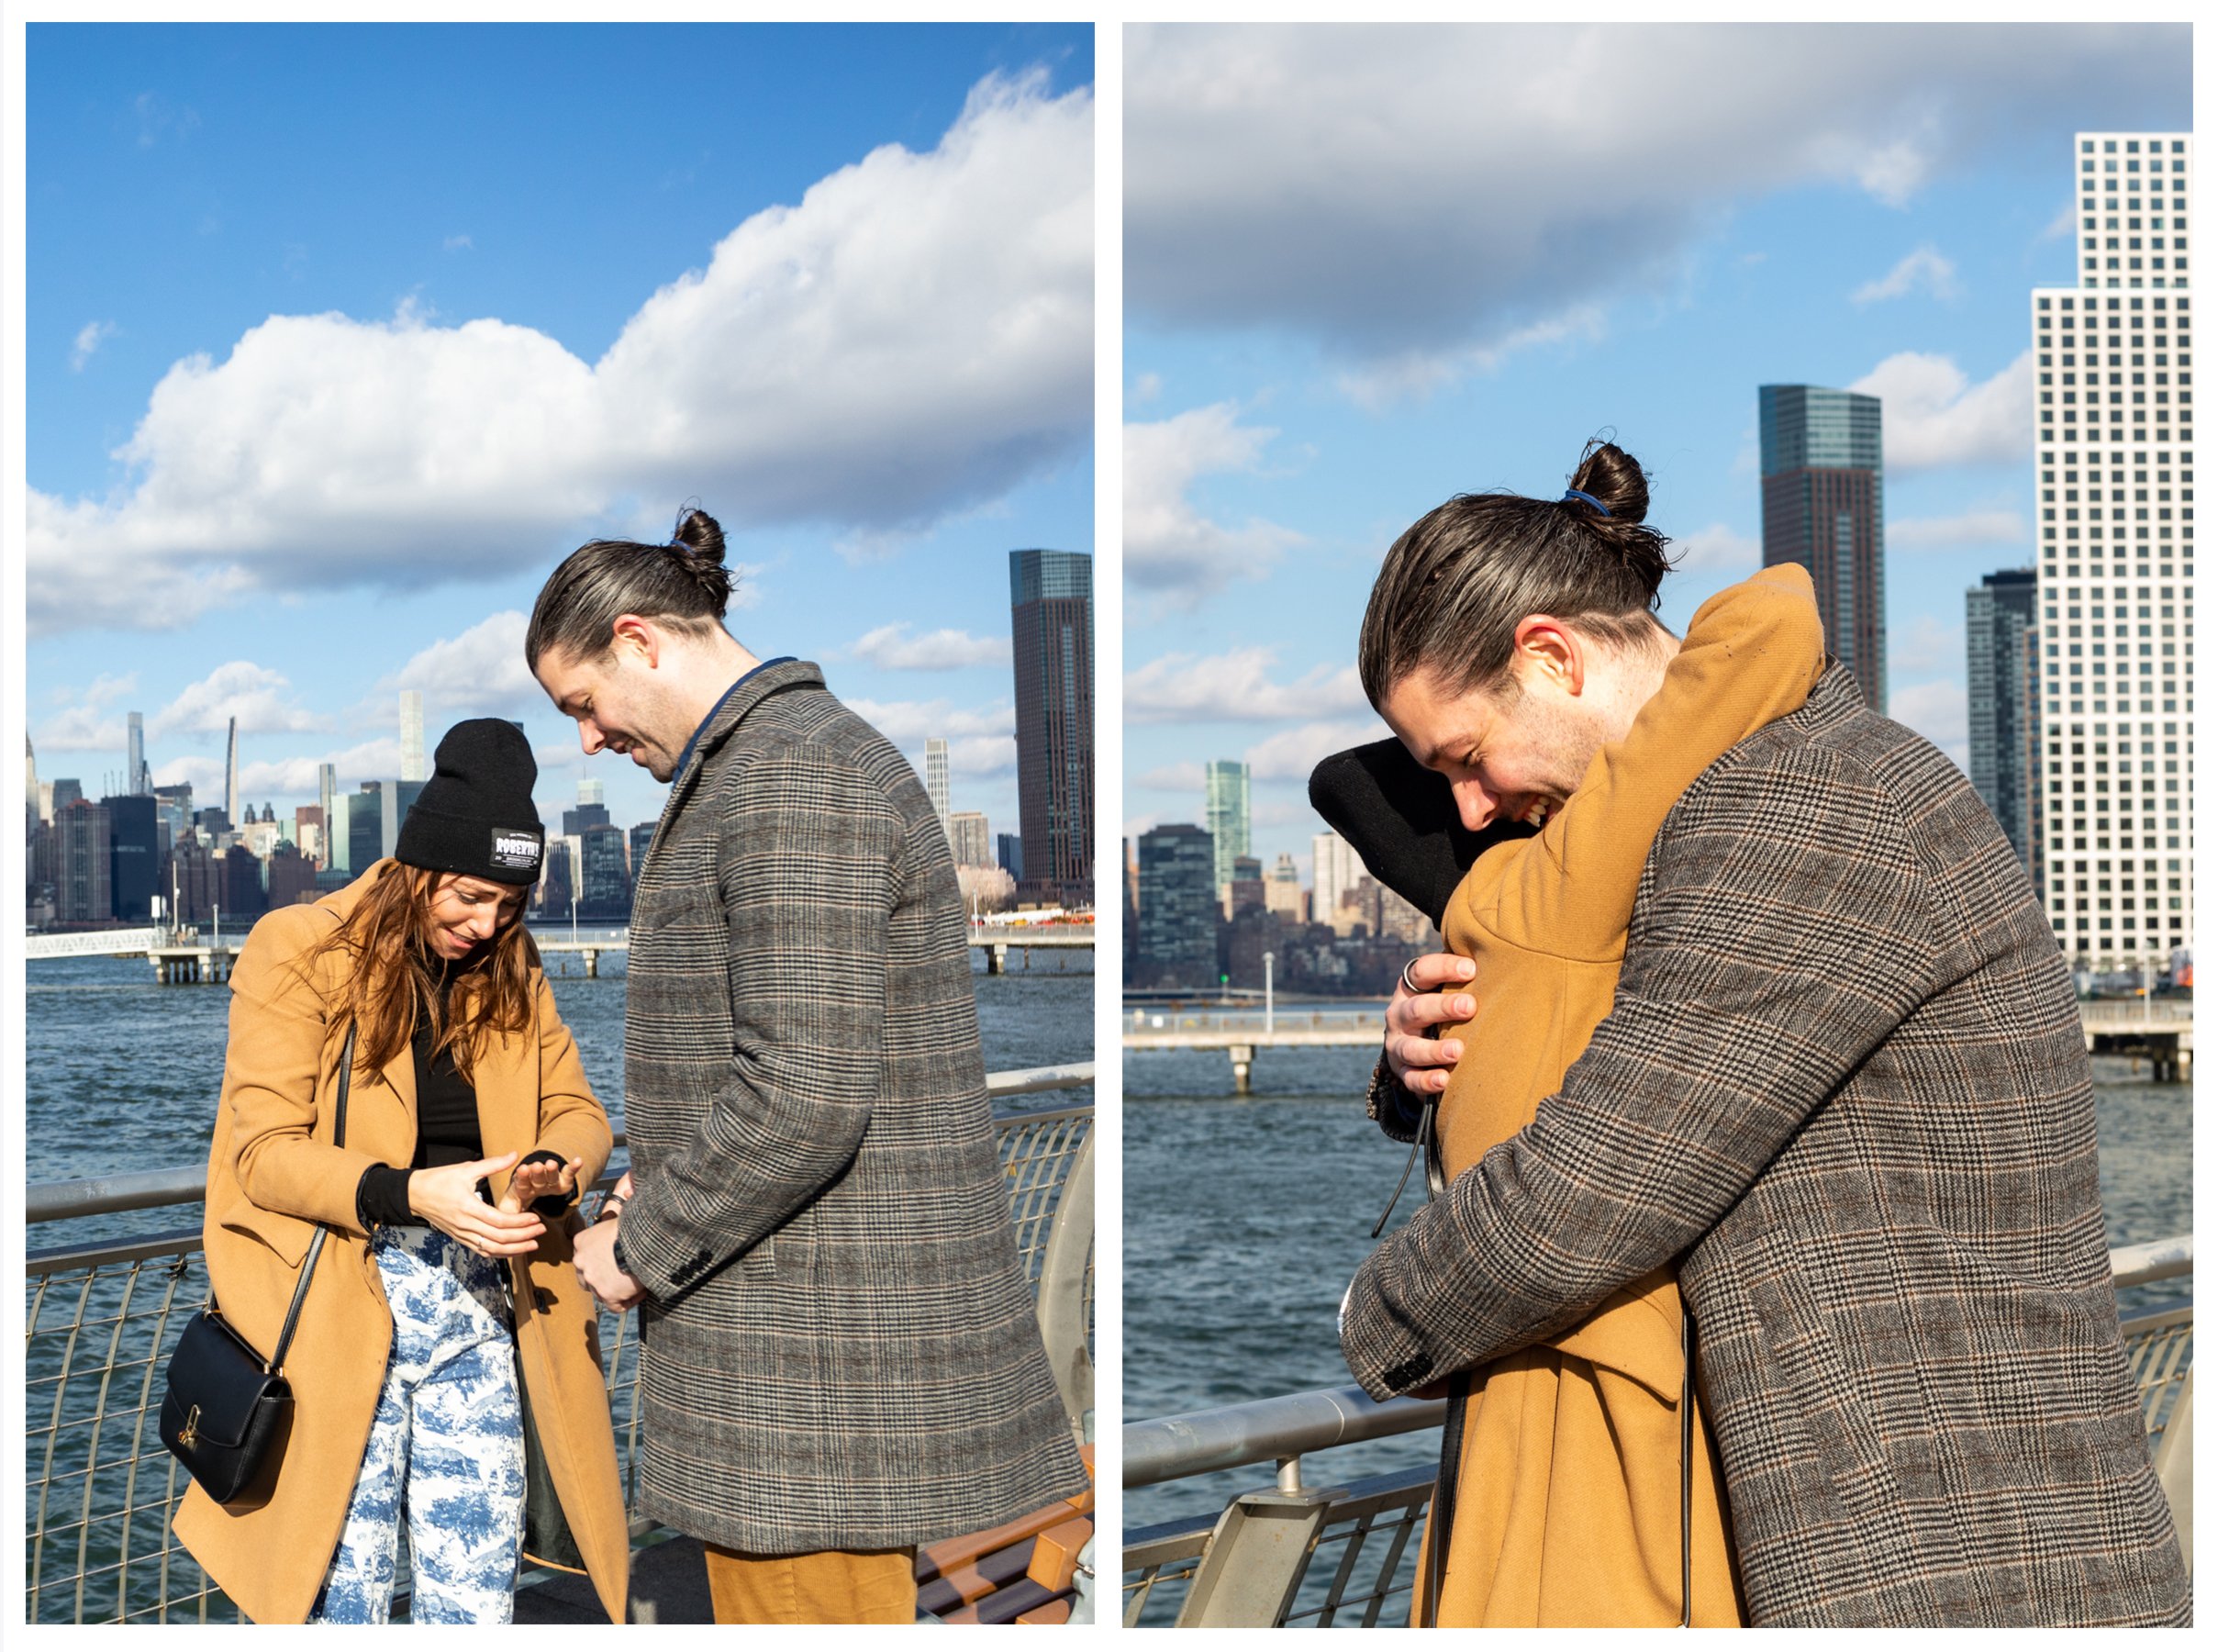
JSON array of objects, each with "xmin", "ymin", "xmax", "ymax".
[{"xmin": 1310, "ymin": 446, "xmax": 2190, "ymax": 1625}]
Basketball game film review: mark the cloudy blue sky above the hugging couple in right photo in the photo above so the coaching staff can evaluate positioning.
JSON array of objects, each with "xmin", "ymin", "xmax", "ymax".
[{"xmin": 1124, "ymin": 25, "xmax": 2191, "ymax": 880}]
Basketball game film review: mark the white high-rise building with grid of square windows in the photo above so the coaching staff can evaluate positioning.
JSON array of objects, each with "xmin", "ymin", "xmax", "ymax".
[{"xmin": 2032, "ymin": 133, "xmax": 2196, "ymax": 971}]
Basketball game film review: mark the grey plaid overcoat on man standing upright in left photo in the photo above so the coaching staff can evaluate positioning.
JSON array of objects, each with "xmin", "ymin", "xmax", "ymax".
[{"xmin": 621, "ymin": 661, "xmax": 1087, "ymax": 1555}]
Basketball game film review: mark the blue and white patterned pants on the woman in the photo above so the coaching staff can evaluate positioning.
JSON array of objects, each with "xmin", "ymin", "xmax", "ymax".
[{"xmin": 313, "ymin": 1226, "xmax": 523, "ymax": 1624}]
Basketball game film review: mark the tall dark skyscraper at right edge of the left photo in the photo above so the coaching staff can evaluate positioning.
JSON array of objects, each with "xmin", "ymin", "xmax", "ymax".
[{"xmin": 1009, "ymin": 550, "xmax": 1094, "ymax": 902}]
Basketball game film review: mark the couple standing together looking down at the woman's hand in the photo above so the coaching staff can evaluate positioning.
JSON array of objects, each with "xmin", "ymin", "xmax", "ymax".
[{"xmin": 162, "ymin": 512, "xmax": 1087, "ymax": 1624}]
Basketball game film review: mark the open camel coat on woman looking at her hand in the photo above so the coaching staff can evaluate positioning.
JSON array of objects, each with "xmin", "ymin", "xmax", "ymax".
[{"xmin": 175, "ymin": 860, "xmax": 630, "ymax": 1624}]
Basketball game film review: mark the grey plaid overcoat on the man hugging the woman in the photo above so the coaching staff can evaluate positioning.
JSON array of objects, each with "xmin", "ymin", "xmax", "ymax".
[{"xmin": 1342, "ymin": 665, "xmax": 2190, "ymax": 1625}]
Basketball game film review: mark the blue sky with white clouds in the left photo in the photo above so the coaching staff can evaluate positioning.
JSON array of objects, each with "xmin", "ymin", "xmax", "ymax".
[{"xmin": 27, "ymin": 25, "xmax": 1094, "ymax": 832}]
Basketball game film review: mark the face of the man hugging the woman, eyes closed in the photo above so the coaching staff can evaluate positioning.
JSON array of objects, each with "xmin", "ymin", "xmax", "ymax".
[{"xmin": 1382, "ymin": 652, "xmax": 1622, "ymax": 832}]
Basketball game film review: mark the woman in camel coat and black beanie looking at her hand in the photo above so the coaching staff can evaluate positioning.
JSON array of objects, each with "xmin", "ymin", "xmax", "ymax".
[{"xmin": 175, "ymin": 719, "xmax": 630, "ymax": 1624}]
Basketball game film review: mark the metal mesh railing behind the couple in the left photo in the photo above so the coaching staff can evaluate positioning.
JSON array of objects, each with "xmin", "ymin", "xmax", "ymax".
[{"xmin": 25, "ymin": 1062, "xmax": 1094, "ymax": 1624}]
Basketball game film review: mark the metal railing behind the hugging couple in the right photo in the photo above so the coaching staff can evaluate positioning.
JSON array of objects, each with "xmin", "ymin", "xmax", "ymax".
[{"xmin": 1122, "ymin": 1235, "xmax": 2193, "ymax": 1627}]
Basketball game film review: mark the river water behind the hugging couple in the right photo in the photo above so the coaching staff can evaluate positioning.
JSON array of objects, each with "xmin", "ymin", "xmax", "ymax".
[{"xmin": 1122, "ymin": 1029, "xmax": 2193, "ymax": 1587}]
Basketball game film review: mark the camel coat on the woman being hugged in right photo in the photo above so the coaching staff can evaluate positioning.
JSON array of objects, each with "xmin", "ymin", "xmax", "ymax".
[{"xmin": 1417, "ymin": 565, "xmax": 1825, "ymax": 1627}]
